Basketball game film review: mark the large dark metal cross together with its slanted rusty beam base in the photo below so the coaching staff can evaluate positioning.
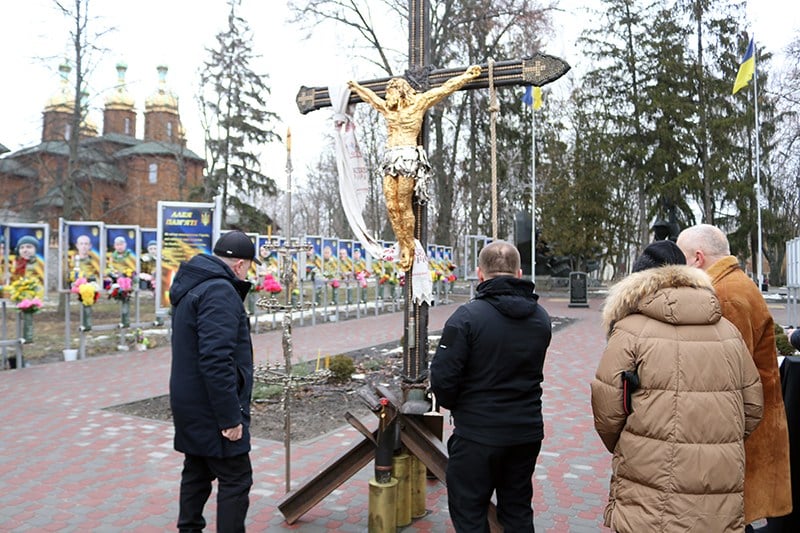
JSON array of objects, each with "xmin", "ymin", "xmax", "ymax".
[{"xmin": 279, "ymin": 0, "xmax": 570, "ymax": 531}]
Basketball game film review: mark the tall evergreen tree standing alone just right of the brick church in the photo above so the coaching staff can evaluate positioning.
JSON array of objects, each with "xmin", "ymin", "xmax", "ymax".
[{"xmin": 199, "ymin": 0, "xmax": 280, "ymax": 230}]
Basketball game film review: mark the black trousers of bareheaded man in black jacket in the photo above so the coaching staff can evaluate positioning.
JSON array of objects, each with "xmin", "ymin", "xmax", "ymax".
[{"xmin": 446, "ymin": 435, "xmax": 542, "ymax": 533}]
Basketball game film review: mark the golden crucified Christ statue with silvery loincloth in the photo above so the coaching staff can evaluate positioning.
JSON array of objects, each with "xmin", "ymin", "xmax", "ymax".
[{"xmin": 347, "ymin": 65, "xmax": 481, "ymax": 271}]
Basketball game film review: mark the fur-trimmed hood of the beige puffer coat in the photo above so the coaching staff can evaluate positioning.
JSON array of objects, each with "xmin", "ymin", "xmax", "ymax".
[{"xmin": 603, "ymin": 265, "xmax": 722, "ymax": 335}]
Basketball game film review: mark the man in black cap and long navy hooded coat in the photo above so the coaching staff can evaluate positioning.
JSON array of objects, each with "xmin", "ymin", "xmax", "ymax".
[{"xmin": 169, "ymin": 231, "xmax": 260, "ymax": 532}]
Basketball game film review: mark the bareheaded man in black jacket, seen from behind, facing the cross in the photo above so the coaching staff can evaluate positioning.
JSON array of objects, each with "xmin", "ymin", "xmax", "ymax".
[{"xmin": 430, "ymin": 241, "xmax": 552, "ymax": 533}]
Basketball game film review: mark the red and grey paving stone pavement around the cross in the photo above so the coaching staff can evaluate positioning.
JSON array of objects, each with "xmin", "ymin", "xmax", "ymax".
[{"xmin": 0, "ymin": 297, "xmax": 788, "ymax": 533}]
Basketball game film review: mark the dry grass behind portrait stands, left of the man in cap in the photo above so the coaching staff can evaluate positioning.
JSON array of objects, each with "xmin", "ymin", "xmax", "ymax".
[{"xmin": 0, "ymin": 292, "xmax": 165, "ymax": 365}]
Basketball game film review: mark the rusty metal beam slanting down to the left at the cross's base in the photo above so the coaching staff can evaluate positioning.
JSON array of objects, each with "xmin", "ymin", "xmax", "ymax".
[{"xmin": 278, "ymin": 432, "xmax": 377, "ymax": 524}]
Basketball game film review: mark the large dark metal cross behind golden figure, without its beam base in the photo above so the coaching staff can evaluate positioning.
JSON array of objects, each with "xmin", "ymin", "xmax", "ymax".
[{"xmin": 296, "ymin": 0, "xmax": 570, "ymax": 383}]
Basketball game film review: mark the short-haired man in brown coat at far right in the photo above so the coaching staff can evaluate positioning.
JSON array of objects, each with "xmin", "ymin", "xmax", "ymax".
[{"xmin": 677, "ymin": 224, "xmax": 792, "ymax": 530}]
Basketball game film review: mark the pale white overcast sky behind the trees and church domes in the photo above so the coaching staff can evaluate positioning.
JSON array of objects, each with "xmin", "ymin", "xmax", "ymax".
[{"xmin": 0, "ymin": 0, "xmax": 800, "ymax": 191}]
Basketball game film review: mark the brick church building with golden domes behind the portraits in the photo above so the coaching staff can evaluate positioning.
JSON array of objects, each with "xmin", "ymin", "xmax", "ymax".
[{"xmin": 0, "ymin": 64, "xmax": 205, "ymax": 230}]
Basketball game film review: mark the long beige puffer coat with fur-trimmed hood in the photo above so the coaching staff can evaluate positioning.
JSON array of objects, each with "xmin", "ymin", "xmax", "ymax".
[{"xmin": 591, "ymin": 256, "xmax": 763, "ymax": 533}]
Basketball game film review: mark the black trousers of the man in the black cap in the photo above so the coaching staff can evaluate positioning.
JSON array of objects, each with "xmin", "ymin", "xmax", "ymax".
[{"xmin": 178, "ymin": 453, "xmax": 253, "ymax": 533}]
